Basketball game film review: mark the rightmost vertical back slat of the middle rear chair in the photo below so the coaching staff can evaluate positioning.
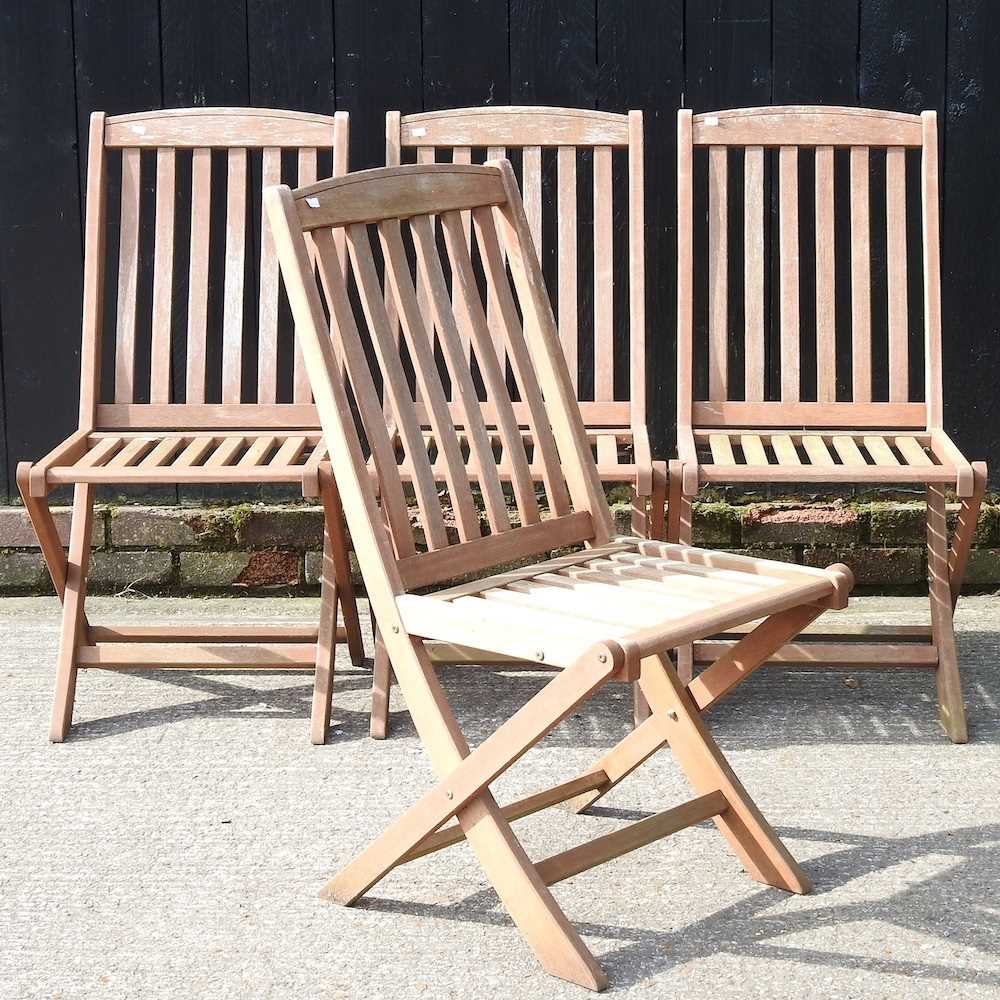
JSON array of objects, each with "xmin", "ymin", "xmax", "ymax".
[{"xmin": 594, "ymin": 146, "xmax": 615, "ymax": 400}]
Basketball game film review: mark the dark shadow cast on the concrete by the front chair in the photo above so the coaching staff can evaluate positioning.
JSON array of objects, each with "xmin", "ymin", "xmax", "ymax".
[{"xmin": 357, "ymin": 810, "xmax": 1000, "ymax": 990}]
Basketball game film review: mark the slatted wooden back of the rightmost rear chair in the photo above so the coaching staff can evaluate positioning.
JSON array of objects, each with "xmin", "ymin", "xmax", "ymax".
[{"xmin": 678, "ymin": 107, "xmax": 942, "ymax": 434}]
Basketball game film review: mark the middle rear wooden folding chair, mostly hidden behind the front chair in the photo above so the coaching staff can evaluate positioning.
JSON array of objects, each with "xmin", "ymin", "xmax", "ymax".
[{"xmin": 371, "ymin": 107, "xmax": 667, "ymax": 738}]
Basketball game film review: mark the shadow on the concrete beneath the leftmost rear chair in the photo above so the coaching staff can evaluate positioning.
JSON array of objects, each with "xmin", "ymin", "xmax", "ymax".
[{"xmin": 67, "ymin": 665, "xmax": 371, "ymax": 745}]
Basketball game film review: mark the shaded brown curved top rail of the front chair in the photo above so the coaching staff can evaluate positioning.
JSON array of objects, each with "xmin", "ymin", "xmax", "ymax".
[{"xmin": 292, "ymin": 163, "xmax": 507, "ymax": 232}]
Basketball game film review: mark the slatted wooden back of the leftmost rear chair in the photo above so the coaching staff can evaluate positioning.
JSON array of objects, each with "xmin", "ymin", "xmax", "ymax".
[{"xmin": 75, "ymin": 108, "xmax": 348, "ymax": 429}]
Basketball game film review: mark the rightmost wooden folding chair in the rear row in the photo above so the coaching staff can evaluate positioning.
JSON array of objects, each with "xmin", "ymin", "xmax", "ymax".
[{"xmin": 668, "ymin": 107, "xmax": 986, "ymax": 743}]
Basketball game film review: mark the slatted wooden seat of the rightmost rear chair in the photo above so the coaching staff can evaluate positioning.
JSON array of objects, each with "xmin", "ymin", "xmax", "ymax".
[{"xmin": 693, "ymin": 428, "xmax": 972, "ymax": 485}]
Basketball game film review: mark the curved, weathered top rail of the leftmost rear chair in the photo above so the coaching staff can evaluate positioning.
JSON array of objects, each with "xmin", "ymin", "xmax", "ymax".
[{"xmin": 104, "ymin": 108, "xmax": 347, "ymax": 149}]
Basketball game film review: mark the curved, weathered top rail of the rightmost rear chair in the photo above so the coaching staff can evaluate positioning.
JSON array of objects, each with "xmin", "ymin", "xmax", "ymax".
[{"xmin": 691, "ymin": 105, "xmax": 935, "ymax": 146}]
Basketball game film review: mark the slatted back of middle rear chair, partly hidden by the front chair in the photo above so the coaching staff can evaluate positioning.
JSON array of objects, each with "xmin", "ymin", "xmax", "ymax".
[{"xmin": 386, "ymin": 107, "xmax": 646, "ymax": 434}]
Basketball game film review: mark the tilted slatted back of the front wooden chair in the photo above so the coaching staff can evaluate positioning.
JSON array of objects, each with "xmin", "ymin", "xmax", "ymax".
[{"xmin": 265, "ymin": 161, "xmax": 611, "ymax": 600}]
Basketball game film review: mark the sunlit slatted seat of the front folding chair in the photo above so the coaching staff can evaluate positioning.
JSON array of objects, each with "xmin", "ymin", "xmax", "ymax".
[{"xmin": 397, "ymin": 538, "xmax": 852, "ymax": 666}]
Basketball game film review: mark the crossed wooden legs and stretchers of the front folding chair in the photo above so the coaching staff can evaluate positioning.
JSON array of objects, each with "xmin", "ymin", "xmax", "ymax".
[{"xmin": 321, "ymin": 605, "xmax": 822, "ymax": 990}]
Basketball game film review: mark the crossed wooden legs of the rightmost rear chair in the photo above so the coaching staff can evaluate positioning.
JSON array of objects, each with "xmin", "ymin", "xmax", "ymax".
[{"xmin": 667, "ymin": 460, "xmax": 986, "ymax": 743}]
